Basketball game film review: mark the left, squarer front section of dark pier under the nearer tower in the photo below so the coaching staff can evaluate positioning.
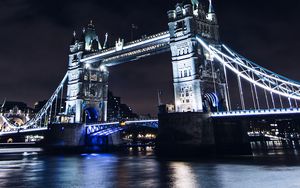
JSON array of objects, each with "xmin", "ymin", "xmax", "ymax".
[{"xmin": 158, "ymin": 112, "xmax": 215, "ymax": 156}]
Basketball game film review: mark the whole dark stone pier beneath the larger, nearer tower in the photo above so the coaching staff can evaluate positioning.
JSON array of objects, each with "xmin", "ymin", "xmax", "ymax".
[{"xmin": 157, "ymin": 112, "xmax": 252, "ymax": 156}]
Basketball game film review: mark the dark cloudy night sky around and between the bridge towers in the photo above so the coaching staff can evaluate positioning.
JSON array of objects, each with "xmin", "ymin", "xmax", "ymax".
[{"xmin": 0, "ymin": 0, "xmax": 300, "ymax": 114}]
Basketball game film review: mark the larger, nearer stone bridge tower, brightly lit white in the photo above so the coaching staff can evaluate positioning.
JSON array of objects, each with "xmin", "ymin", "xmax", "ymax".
[{"xmin": 168, "ymin": 1, "xmax": 228, "ymax": 112}]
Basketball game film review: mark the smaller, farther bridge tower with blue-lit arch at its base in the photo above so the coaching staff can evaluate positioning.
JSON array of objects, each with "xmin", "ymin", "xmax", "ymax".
[{"xmin": 66, "ymin": 21, "xmax": 109, "ymax": 123}]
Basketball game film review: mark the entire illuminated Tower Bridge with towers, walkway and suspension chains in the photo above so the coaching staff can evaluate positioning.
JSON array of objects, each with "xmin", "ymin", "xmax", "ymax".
[{"xmin": 0, "ymin": 0, "xmax": 300, "ymax": 154}]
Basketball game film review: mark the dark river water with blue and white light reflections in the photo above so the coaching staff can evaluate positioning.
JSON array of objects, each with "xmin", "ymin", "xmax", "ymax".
[{"xmin": 0, "ymin": 148, "xmax": 300, "ymax": 188}]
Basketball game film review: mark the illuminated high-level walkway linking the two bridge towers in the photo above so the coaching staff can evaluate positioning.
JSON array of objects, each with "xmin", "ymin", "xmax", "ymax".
[{"xmin": 80, "ymin": 31, "xmax": 170, "ymax": 67}]
